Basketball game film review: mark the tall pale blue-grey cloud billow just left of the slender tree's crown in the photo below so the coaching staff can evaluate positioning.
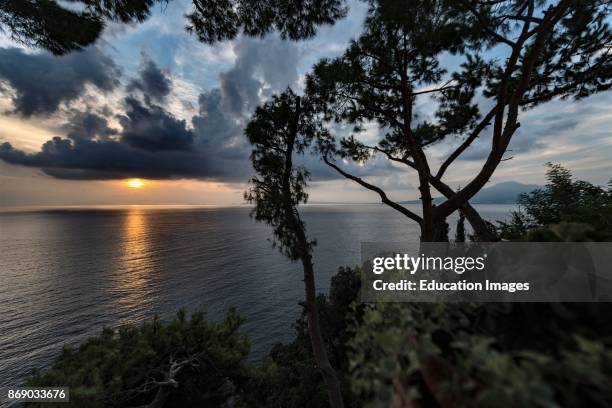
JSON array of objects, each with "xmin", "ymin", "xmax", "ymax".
[{"xmin": 185, "ymin": 37, "xmax": 299, "ymax": 181}]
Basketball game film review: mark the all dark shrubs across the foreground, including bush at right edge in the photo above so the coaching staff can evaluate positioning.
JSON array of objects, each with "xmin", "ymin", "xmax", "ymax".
[{"xmin": 27, "ymin": 165, "xmax": 612, "ymax": 407}]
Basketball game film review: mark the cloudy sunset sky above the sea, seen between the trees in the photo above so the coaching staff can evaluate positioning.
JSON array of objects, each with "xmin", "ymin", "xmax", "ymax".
[{"xmin": 0, "ymin": 1, "xmax": 612, "ymax": 207}]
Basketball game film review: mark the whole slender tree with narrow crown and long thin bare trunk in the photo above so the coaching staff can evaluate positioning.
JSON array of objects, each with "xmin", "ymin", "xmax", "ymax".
[{"xmin": 245, "ymin": 89, "xmax": 343, "ymax": 407}]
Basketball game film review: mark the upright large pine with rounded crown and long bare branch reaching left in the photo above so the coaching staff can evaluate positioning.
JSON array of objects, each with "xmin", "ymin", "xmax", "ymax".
[{"xmin": 307, "ymin": 0, "xmax": 494, "ymax": 240}]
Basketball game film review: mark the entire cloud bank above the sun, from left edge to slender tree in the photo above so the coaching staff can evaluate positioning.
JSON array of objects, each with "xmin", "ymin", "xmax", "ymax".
[{"xmin": 0, "ymin": 39, "xmax": 298, "ymax": 181}]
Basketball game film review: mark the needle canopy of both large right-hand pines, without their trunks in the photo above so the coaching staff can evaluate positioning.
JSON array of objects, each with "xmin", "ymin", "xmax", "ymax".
[{"xmin": 306, "ymin": 0, "xmax": 612, "ymax": 166}]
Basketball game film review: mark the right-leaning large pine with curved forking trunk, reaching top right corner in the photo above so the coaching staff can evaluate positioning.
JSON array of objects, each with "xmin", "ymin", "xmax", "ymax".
[{"xmin": 434, "ymin": 0, "xmax": 612, "ymax": 228}]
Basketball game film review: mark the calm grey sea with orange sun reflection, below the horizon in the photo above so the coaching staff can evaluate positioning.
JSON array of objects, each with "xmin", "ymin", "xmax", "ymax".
[{"xmin": 0, "ymin": 205, "xmax": 511, "ymax": 386}]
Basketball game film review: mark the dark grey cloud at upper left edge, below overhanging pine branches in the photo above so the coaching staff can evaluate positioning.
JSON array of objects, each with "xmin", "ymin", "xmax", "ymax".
[{"xmin": 0, "ymin": 47, "xmax": 120, "ymax": 116}]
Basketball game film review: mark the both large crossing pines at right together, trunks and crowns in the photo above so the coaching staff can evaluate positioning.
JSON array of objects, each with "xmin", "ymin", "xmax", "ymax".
[{"xmin": 307, "ymin": 0, "xmax": 612, "ymax": 241}]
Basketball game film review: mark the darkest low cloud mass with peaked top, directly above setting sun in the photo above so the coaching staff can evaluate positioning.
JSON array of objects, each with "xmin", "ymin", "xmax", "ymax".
[{"xmin": 0, "ymin": 54, "xmax": 201, "ymax": 179}]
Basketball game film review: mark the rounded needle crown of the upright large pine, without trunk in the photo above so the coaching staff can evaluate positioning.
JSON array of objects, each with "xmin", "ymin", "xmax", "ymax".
[{"xmin": 307, "ymin": 0, "xmax": 485, "ymax": 161}]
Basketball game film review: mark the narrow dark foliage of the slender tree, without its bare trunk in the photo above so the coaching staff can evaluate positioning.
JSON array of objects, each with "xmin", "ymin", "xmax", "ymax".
[{"xmin": 244, "ymin": 89, "xmax": 321, "ymax": 260}]
